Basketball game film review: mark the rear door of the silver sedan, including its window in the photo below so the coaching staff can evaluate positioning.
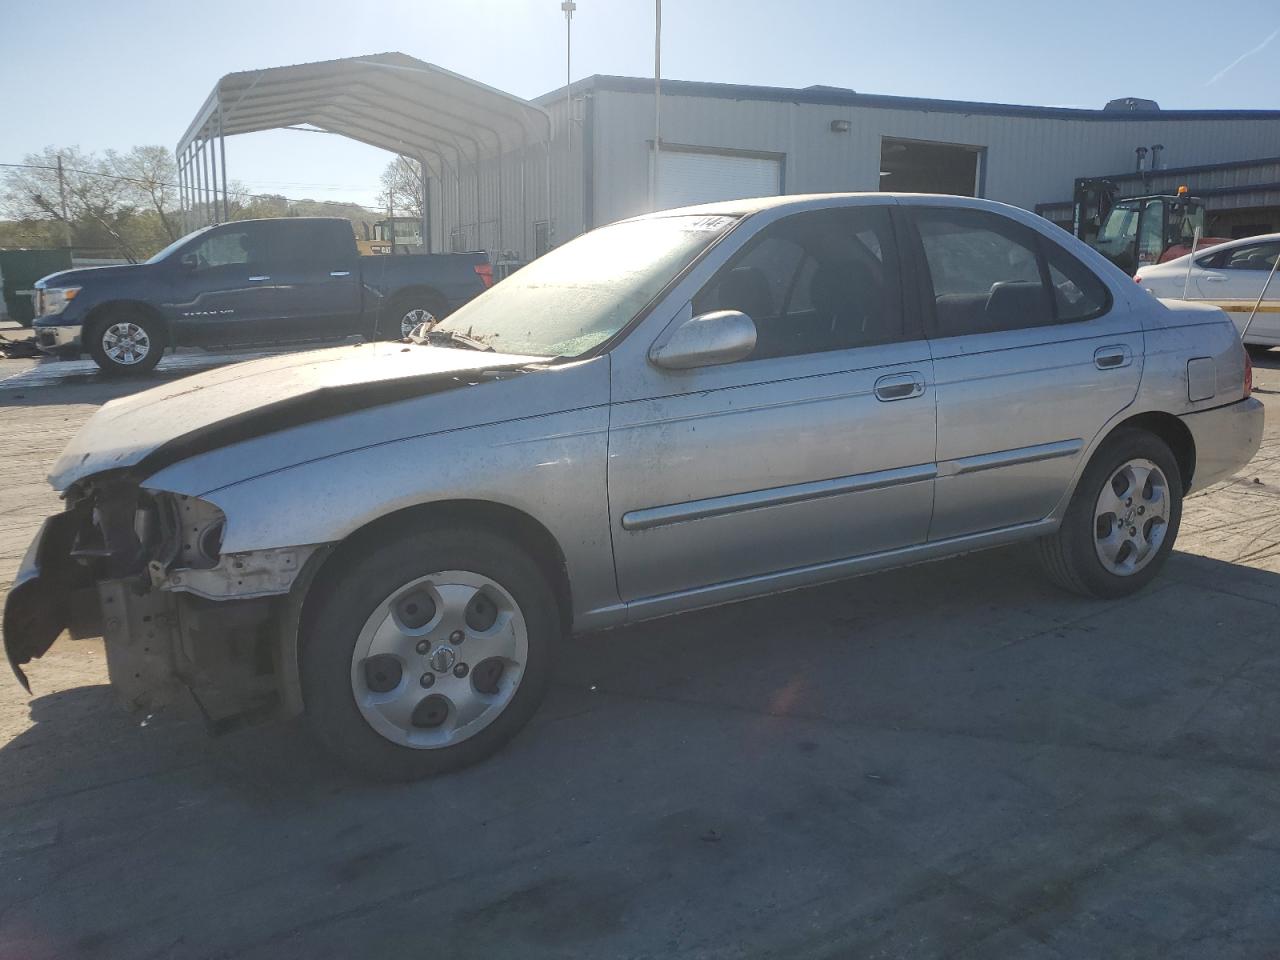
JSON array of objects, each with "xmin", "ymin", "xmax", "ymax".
[{"xmin": 904, "ymin": 198, "xmax": 1143, "ymax": 540}]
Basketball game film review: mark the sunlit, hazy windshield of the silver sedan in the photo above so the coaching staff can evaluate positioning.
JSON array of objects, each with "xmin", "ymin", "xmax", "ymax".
[{"xmin": 435, "ymin": 215, "xmax": 737, "ymax": 357}]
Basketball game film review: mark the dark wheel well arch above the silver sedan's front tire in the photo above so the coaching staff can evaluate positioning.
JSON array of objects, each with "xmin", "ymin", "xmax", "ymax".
[{"xmin": 301, "ymin": 500, "xmax": 572, "ymax": 640}]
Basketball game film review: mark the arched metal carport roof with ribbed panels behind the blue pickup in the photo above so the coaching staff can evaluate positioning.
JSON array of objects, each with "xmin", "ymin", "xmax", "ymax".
[{"xmin": 175, "ymin": 52, "xmax": 552, "ymax": 256}]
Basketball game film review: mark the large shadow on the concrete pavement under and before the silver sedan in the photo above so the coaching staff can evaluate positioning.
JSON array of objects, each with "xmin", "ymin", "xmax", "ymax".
[{"xmin": 0, "ymin": 550, "xmax": 1280, "ymax": 960}]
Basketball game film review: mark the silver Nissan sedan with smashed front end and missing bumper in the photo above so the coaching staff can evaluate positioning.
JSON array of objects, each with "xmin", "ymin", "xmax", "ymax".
[{"xmin": 5, "ymin": 193, "xmax": 1262, "ymax": 778}]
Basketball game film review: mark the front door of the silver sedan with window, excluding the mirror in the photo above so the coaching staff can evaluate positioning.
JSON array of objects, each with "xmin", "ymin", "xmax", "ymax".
[{"xmin": 608, "ymin": 202, "xmax": 934, "ymax": 602}]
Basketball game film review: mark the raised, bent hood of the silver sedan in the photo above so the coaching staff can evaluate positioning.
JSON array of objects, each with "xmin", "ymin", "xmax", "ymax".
[{"xmin": 49, "ymin": 343, "xmax": 545, "ymax": 490}]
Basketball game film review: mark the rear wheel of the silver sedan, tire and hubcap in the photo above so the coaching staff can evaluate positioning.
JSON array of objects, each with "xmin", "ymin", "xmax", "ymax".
[{"xmin": 1039, "ymin": 429, "xmax": 1183, "ymax": 599}]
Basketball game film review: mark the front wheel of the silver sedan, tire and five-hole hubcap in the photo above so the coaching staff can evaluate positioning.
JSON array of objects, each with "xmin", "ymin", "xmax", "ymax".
[{"xmin": 302, "ymin": 527, "xmax": 561, "ymax": 781}]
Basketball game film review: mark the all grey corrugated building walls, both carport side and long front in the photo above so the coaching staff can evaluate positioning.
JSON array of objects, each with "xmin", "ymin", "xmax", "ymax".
[{"xmin": 430, "ymin": 87, "xmax": 1280, "ymax": 260}]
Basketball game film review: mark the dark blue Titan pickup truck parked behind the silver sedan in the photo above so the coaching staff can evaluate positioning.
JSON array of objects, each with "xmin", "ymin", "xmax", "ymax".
[{"xmin": 32, "ymin": 216, "xmax": 492, "ymax": 375}]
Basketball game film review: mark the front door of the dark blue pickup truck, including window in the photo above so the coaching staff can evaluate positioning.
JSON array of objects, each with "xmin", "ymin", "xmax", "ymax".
[{"xmin": 164, "ymin": 223, "xmax": 275, "ymax": 344}]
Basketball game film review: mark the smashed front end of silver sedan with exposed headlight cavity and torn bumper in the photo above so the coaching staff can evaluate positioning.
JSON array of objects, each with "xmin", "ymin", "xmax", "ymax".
[{"xmin": 4, "ymin": 475, "xmax": 317, "ymax": 730}]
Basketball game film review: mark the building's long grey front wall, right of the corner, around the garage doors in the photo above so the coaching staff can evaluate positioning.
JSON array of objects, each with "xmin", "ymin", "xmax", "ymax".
[{"xmin": 593, "ymin": 90, "xmax": 1280, "ymax": 225}]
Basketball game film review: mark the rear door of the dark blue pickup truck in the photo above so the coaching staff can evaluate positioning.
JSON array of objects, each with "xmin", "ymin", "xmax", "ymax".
[{"xmin": 269, "ymin": 219, "xmax": 362, "ymax": 340}]
